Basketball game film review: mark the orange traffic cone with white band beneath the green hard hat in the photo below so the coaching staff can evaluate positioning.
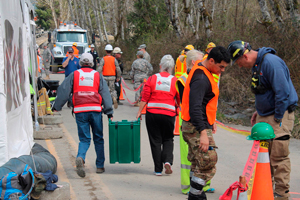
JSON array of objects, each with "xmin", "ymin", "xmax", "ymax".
[{"xmin": 251, "ymin": 141, "xmax": 274, "ymax": 200}]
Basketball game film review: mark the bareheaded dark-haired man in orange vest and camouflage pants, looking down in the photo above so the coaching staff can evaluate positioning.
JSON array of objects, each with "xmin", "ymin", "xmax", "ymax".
[{"xmin": 181, "ymin": 46, "xmax": 230, "ymax": 200}]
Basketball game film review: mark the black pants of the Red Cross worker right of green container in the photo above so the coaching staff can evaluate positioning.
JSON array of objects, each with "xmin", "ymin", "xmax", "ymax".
[{"xmin": 146, "ymin": 112, "xmax": 175, "ymax": 172}]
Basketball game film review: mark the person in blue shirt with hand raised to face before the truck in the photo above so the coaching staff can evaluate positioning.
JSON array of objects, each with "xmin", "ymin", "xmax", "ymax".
[{"xmin": 62, "ymin": 47, "xmax": 80, "ymax": 77}]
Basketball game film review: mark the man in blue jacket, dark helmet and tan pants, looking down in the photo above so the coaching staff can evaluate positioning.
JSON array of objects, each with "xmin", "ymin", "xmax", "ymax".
[{"xmin": 228, "ymin": 40, "xmax": 298, "ymax": 199}]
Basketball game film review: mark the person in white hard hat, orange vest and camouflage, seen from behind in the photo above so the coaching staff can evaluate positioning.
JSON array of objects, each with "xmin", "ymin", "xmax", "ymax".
[{"xmin": 98, "ymin": 44, "xmax": 121, "ymax": 109}]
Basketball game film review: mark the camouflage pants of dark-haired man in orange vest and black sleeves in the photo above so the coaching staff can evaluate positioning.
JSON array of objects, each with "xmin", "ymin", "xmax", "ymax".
[{"xmin": 181, "ymin": 120, "xmax": 218, "ymax": 182}]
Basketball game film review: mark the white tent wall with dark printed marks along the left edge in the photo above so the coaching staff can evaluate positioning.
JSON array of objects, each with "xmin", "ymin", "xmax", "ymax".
[{"xmin": 0, "ymin": 0, "xmax": 34, "ymax": 165}]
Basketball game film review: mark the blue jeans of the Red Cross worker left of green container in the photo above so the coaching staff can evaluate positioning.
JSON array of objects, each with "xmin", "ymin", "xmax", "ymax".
[{"xmin": 75, "ymin": 112, "xmax": 105, "ymax": 168}]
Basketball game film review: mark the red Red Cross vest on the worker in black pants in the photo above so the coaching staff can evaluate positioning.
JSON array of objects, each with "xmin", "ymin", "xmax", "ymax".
[{"xmin": 147, "ymin": 72, "xmax": 177, "ymax": 116}]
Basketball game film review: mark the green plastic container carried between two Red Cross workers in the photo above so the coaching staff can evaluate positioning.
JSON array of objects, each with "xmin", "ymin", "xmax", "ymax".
[{"xmin": 109, "ymin": 119, "xmax": 141, "ymax": 164}]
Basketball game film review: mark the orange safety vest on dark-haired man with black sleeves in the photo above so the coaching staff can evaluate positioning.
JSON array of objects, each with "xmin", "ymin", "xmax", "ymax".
[{"xmin": 181, "ymin": 61, "xmax": 219, "ymax": 125}]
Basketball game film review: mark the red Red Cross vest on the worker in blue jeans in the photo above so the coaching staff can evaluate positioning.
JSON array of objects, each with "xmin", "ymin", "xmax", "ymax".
[{"xmin": 73, "ymin": 68, "xmax": 102, "ymax": 113}]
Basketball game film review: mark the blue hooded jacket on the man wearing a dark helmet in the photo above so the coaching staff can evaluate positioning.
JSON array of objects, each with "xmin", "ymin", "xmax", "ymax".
[{"xmin": 252, "ymin": 47, "xmax": 298, "ymax": 119}]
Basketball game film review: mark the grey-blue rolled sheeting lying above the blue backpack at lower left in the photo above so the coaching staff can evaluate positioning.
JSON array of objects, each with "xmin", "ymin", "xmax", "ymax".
[{"xmin": 0, "ymin": 143, "xmax": 57, "ymax": 178}]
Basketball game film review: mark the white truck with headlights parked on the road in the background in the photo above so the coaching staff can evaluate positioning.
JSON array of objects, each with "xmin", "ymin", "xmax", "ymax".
[{"xmin": 48, "ymin": 22, "xmax": 90, "ymax": 72}]
